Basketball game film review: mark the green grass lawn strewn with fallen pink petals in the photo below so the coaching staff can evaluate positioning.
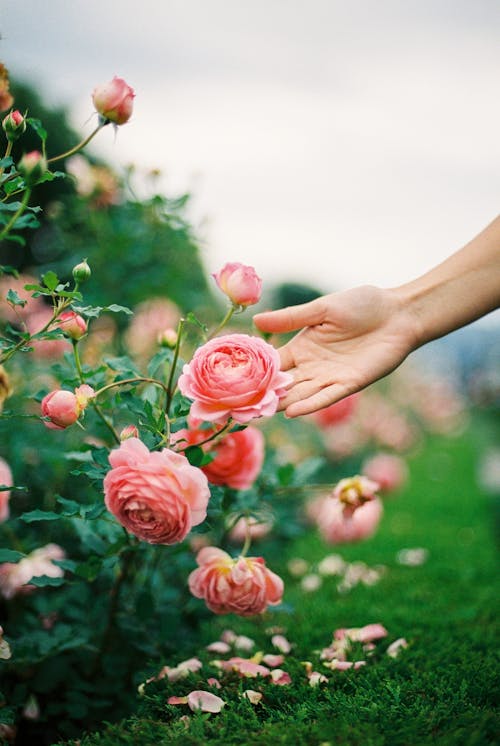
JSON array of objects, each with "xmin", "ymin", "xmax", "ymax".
[{"xmin": 60, "ymin": 428, "xmax": 500, "ymax": 746}]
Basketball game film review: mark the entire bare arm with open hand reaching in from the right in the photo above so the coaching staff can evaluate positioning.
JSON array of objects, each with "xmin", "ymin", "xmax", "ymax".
[{"xmin": 254, "ymin": 217, "xmax": 500, "ymax": 417}]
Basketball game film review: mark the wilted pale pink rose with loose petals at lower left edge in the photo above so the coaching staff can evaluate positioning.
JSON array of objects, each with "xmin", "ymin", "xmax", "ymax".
[{"xmin": 0, "ymin": 544, "xmax": 65, "ymax": 599}]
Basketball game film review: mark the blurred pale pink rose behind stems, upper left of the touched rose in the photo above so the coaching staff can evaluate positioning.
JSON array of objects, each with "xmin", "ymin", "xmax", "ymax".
[{"xmin": 125, "ymin": 298, "xmax": 181, "ymax": 357}]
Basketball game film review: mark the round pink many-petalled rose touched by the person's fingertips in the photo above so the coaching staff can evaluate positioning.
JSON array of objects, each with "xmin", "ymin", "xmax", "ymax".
[{"xmin": 178, "ymin": 334, "xmax": 292, "ymax": 424}]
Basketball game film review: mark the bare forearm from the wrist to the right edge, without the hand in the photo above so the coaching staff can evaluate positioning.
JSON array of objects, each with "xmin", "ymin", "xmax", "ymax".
[{"xmin": 394, "ymin": 212, "xmax": 500, "ymax": 347}]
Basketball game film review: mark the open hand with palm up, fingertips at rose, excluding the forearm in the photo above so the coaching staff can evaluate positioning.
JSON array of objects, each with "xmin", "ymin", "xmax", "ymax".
[{"xmin": 254, "ymin": 286, "xmax": 418, "ymax": 417}]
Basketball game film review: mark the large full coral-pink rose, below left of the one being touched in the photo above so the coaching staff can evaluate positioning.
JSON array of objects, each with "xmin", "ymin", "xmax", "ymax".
[{"xmin": 104, "ymin": 438, "xmax": 210, "ymax": 544}]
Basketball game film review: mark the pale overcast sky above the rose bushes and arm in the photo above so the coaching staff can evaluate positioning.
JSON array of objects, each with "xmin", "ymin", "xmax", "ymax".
[{"xmin": 0, "ymin": 0, "xmax": 500, "ymax": 308}]
